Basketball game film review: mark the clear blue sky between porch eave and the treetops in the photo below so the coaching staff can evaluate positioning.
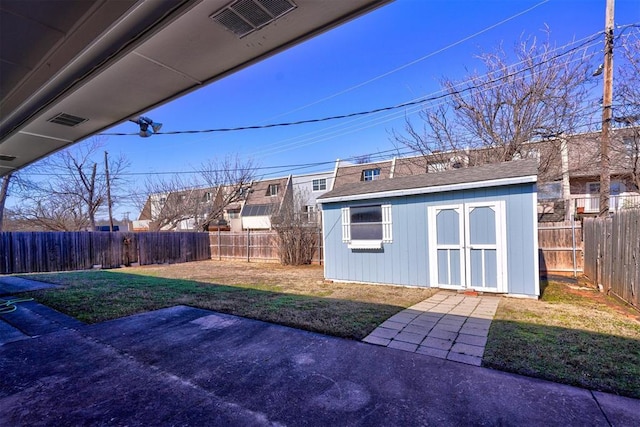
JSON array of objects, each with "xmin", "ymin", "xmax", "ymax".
[{"xmin": 102, "ymin": 0, "xmax": 640, "ymax": 182}]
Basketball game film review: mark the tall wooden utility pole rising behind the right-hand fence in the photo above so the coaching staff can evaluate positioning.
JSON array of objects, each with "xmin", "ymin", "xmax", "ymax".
[{"xmin": 600, "ymin": 0, "xmax": 614, "ymax": 217}]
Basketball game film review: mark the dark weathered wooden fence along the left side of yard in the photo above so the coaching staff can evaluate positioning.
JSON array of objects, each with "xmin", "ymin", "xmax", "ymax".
[{"xmin": 0, "ymin": 231, "xmax": 211, "ymax": 274}]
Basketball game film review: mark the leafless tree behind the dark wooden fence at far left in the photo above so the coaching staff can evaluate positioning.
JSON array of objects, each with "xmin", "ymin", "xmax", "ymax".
[{"xmin": 11, "ymin": 138, "xmax": 128, "ymax": 230}]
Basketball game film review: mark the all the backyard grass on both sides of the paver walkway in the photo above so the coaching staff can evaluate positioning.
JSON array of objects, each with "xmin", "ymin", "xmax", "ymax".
[{"xmin": 17, "ymin": 261, "xmax": 640, "ymax": 398}]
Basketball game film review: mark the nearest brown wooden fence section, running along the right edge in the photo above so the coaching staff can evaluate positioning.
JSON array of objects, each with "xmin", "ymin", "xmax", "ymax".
[{"xmin": 584, "ymin": 209, "xmax": 640, "ymax": 308}]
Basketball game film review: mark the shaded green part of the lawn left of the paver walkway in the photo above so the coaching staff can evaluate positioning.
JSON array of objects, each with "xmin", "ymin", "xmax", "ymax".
[{"xmin": 20, "ymin": 271, "xmax": 432, "ymax": 339}]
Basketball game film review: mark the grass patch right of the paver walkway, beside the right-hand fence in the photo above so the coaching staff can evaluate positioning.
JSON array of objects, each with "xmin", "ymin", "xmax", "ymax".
[{"xmin": 483, "ymin": 282, "xmax": 640, "ymax": 398}]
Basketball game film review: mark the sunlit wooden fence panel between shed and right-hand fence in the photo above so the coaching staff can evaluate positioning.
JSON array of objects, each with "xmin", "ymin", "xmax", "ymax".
[{"xmin": 538, "ymin": 221, "xmax": 583, "ymax": 274}]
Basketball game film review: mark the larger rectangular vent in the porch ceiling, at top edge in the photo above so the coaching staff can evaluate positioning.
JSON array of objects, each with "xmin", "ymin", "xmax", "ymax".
[{"xmin": 211, "ymin": 0, "xmax": 296, "ymax": 37}]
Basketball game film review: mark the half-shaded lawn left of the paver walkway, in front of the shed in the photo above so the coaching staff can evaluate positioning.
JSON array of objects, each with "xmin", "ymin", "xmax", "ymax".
[{"xmin": 23, "ymin": 261, "xmax": 435, "ymax": 340}]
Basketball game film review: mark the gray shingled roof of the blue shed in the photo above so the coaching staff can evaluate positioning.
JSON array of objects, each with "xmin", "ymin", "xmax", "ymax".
[{"xmin": 318, "ymin": 159, "xmax": 538, "ymax": 202}]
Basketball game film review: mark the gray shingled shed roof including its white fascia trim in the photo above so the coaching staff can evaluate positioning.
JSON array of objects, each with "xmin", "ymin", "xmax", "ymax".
[{"xmin": 318, "ymin": 159, "xmax": 538, "ymax": 203}]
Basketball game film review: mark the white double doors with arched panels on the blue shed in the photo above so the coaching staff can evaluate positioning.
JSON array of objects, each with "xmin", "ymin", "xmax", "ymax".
[{"xmin": 429, "ymin": 202, "xmax": 506, "ymax": 292}]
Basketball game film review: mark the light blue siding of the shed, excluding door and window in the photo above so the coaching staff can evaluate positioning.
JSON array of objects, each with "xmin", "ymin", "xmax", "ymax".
[{"xmin": 322, "ymin": 184, "xmax": 538, "ymax": 295}]
